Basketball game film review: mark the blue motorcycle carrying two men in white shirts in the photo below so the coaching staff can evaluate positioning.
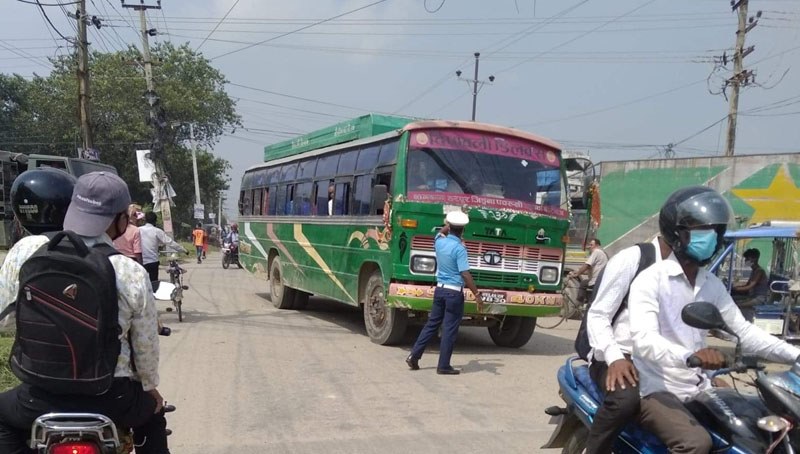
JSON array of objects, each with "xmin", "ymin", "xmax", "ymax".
[{"xmin": 542, "ymin": 303, "xmax": 800, "ymax": 454}]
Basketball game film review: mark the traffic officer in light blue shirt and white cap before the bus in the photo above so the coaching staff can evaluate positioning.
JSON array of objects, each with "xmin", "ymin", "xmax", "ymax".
[{"xmin": 406, "ymin": 211, "xmax": 483, "ymax": 375}]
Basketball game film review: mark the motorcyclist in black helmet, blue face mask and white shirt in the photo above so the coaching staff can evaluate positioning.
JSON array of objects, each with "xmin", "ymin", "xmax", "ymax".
[{"xmin": 628, "ymin": 186, "xmax": 800, "ymax": 453}]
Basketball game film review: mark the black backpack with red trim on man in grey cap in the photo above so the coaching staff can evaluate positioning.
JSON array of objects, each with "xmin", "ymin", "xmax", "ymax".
[{"xmin": 0, "ymin": 231, "xmax": 121, "ymax": 395}]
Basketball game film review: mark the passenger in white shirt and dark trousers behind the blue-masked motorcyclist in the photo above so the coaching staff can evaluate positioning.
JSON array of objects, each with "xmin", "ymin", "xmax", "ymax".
[{"xmin": 586, "ymin": 213, "xmax": 672, "ymax": 454}]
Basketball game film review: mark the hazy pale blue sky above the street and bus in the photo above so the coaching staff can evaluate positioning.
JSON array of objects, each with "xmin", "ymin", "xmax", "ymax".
[{"xmin": 0, "ymin": 0, "xmax": 800, "ymax": 218}]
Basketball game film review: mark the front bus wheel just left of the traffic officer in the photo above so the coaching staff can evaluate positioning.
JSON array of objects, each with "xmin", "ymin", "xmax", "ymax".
[{"xmin": 361, "ymin": 272, "xmax": 408, "ymax": 345}]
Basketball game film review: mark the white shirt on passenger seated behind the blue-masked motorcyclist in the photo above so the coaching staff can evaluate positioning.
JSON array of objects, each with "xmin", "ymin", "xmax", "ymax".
[{"xmin": 586, "ymin": 238, "xmax": 661, "ymax": 364}]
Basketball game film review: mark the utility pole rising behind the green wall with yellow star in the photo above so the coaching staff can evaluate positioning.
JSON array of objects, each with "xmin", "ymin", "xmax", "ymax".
[{"xmin": 725, "ymin": 0, "xmax": 761, "ymax": 156}]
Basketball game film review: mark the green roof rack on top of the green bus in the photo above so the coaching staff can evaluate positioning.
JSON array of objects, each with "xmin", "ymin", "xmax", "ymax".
[{"xmin": 264, "ymin": 114, "xmax": 417, "ymax": 162}]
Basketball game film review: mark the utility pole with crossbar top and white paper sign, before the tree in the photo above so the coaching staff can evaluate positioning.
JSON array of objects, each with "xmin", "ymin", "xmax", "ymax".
[{"xmin": 122, "ymin": 0, "xmax": 174, "ymax": 237}]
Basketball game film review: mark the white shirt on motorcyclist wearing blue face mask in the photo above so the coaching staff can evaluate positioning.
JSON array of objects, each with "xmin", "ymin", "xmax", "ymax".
[{"xmin": 629, "ymin": 256, "xmax": 800, "ymax": 401}]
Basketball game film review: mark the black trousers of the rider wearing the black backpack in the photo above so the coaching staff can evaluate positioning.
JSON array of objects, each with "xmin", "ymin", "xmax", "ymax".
[{"xmin": 0, "ymin": 378, "xmax": 169, "ymax": 454}]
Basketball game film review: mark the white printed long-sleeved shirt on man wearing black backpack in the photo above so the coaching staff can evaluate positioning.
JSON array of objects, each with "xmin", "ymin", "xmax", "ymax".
[{"xmin": 0, "ymin": 234, "xmax": 159, "ymax": 391}]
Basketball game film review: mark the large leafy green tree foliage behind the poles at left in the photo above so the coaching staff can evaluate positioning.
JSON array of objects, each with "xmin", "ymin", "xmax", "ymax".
[{"xmin": 0, "ymin": 43, "xmax": 240, "ymax": 238}]
